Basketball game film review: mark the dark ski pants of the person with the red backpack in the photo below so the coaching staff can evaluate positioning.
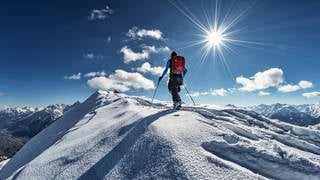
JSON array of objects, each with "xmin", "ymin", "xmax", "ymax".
[{"xmin": 168, "ymin": 74, "xmax": 183, "ymax": 103}]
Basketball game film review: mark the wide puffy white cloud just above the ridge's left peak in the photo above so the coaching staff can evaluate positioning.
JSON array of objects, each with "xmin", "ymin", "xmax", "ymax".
[{"xmin": 87, "ymin": 69, "xmax": 154, "ymax": 92}]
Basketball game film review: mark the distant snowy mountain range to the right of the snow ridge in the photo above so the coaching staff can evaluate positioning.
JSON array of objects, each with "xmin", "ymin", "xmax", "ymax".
[{"xmin": 250, "ymin": 103, "xmax": 320, "ymax": 126}]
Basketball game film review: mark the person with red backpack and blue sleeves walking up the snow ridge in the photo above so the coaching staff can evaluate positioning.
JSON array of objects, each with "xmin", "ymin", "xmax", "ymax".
[{"xmin": 158, "ymin": 51, "xmax": 187, "ymax": 109}]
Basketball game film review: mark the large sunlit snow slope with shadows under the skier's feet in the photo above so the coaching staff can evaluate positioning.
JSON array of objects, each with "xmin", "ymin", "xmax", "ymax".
[{"xmin": 0, "ymin": 91, "xmax": 320, "ymax": 180}]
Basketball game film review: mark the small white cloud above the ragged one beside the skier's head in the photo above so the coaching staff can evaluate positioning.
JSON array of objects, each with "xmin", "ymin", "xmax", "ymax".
[{"xmin": 127, "ymin": 27, "xmax": 163, "ymax": 40}]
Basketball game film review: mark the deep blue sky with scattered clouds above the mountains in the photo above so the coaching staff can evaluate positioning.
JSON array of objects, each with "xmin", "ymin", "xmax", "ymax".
[{"xmin": 0, "ymin": 0, "xmax": 320, "ymax": 106}]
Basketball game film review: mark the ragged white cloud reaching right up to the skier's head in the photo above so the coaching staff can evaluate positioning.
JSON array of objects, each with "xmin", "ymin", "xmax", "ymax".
[{"xmin": 120, "ymin": 45, "xmax": 170, "ymax": 64}]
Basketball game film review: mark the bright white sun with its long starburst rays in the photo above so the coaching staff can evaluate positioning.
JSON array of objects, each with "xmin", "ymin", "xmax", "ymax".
[{"xmin": 168, "ymin": 0, "xmax": 279, "ymax": 84}]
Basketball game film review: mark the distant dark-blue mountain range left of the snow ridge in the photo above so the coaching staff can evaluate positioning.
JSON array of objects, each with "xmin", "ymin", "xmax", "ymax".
[{"xmin": 0, "ymin": 102, "xmax": 80, "ymax": 161}]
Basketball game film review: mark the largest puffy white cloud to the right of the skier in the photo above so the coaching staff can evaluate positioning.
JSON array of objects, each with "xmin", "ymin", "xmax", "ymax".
[{"xmin": 236, "ymin": 68, "xmax": 284, "ymax": 91}]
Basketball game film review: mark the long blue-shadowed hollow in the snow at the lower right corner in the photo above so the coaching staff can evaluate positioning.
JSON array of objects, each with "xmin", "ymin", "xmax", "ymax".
[{"xmin": 203, "ymin": 141, "xmax": 320, "ymax": 180}]
